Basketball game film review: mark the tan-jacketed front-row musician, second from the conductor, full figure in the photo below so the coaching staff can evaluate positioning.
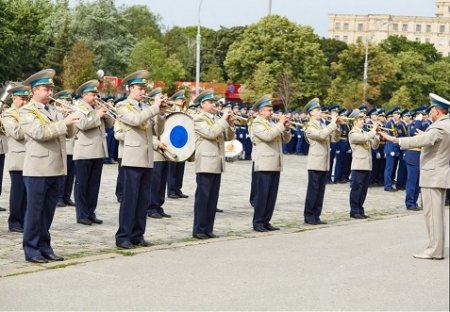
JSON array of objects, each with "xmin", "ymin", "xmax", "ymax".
[{"xmin": 304, "ymin": 98, "xmax": 339, "ymax": 225}]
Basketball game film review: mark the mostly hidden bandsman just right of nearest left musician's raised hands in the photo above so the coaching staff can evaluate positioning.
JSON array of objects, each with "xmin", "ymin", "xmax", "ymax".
[{"xmin": 54, "ymin": 90, "xmax": 75, "ymax": 207}]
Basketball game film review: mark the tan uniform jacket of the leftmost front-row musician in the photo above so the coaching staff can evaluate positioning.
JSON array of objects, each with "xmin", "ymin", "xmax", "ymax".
[{"xmin": 20, "ymin": 99, "xmax": 75, "ymax": 177}]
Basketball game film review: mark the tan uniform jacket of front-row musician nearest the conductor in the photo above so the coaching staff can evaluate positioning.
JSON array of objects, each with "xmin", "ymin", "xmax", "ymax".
[{"xmin": 348, "ymin": 127, "xmax": 380, "ymax": 171}]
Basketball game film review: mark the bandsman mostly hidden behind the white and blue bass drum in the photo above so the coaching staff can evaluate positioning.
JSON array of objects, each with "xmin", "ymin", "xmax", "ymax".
[{"xmin": 167, "ymin": 90, "xmax": 189, "ymax": 199}]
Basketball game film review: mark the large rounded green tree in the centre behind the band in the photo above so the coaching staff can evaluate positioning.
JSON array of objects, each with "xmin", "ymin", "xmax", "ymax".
[{"xmin": 225, "ymin": 15, "xmax": 329, "ymax": 105}]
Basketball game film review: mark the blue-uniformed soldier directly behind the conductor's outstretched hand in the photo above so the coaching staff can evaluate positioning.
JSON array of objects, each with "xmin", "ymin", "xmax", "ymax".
[{"xmin": 384, "ymin": 106, "xmax": 400, "ymax": 192}]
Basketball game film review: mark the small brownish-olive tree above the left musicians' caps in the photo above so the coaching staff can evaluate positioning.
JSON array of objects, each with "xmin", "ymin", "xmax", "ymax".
[{"xmin": 62, "ymin": 42, "xmax": 96, "ymax": 89}]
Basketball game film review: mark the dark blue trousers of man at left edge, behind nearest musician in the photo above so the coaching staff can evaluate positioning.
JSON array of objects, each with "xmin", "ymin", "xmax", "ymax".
[{"xmin": 8, "ymin": 171, "xmax": 27, "ymax": 229}]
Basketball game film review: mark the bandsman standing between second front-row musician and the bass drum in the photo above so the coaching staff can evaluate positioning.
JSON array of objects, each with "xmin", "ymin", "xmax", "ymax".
[{"xmin": 147, "ymin": 88, "xmax": 171, "ymax": 219}]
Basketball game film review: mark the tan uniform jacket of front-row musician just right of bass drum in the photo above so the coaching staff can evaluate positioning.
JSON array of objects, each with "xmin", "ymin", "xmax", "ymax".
[{"xmin": 194, "ymin": 112, "xmax": 234, "ymax": 173}]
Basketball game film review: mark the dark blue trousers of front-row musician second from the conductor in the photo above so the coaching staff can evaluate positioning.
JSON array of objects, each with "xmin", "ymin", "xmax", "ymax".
[{"xmin": 303, "ymin": 170, "xmax": 327, "ymax": 222}]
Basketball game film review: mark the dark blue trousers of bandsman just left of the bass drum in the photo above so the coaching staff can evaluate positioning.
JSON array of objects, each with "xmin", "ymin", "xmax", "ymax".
[{"xmin": 148, "ymin": 161, "xmax": 169, "ymax": 214}]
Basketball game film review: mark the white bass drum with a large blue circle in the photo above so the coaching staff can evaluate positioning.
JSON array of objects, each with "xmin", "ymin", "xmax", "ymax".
[{"xmin": 160, "ymin": 112, "xmax": 195, "ymax": 162}]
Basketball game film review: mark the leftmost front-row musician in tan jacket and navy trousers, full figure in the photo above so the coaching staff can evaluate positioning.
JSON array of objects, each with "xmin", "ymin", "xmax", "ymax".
[{"xmin": 19, "ymin": 69, "xmax": 79, "ymax": 263}]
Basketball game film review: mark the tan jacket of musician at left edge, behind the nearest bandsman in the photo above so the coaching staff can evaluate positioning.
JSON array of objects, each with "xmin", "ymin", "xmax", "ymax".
[{"xmin": 3, "ymin": 105, "xmax": 25, "ymax": 171}]
